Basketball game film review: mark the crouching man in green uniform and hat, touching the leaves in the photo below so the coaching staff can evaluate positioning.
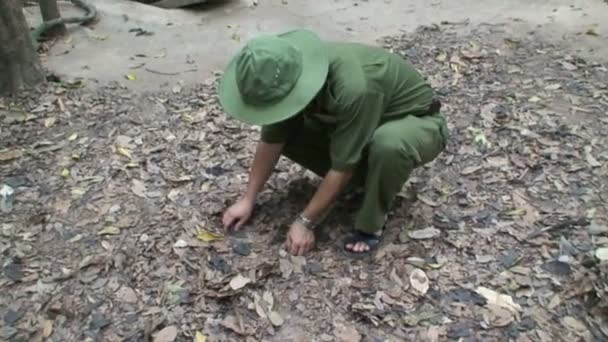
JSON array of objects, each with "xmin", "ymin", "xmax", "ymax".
[{"xmin": 219, "ymin": 30, "xmax": 448, "ymax": 257}]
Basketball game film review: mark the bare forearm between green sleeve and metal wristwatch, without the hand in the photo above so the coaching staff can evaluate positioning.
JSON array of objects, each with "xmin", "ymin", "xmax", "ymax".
[{"xmin": 302, "ymin": 170, "xmax": 352, "ymax": 221}]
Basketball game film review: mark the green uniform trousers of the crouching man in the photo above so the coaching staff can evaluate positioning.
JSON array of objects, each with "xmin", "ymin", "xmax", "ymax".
[{"xmin": 283, "ymin": 113, "xmax": 449, "ymax": 233}]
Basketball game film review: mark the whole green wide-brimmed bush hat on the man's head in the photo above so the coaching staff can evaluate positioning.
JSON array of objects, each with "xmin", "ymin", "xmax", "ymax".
[{"xmin": 219, "ymin": 29, "xmax": 329, "ymax": 125}]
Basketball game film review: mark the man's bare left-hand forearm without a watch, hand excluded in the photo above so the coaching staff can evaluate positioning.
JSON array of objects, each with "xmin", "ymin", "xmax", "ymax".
[{"xmin": 243, "ymin": 141, "xmax": 285, "ymax": 203}]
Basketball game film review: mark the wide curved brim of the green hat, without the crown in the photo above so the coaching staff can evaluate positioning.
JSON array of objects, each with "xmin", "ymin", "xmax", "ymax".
[{"xmin": 219, "ymin": 30, "xmax": 329, "ymax": 125}]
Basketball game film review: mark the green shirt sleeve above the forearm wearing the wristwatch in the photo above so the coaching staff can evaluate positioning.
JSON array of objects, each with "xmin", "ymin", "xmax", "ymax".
[{"xmin": 330, "ymin": 91, "xmax": 383, "ymax": 171}]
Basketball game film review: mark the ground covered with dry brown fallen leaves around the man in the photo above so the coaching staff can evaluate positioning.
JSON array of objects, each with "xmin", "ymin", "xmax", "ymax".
[{"xmin": 0, "ymin": 0, "xmax": 608, "ymax": 342}]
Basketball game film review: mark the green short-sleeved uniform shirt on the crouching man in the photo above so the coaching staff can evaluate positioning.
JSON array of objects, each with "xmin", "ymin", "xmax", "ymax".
[{"xmin": 262, "ymin": 43, "xmax": 433, "ymax": 171}]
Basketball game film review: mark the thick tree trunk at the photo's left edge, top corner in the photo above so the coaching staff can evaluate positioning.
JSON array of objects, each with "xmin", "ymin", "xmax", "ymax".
[{"xmin": 0, "ymin": 0, "xmax": 45, "ymax": 93}]
